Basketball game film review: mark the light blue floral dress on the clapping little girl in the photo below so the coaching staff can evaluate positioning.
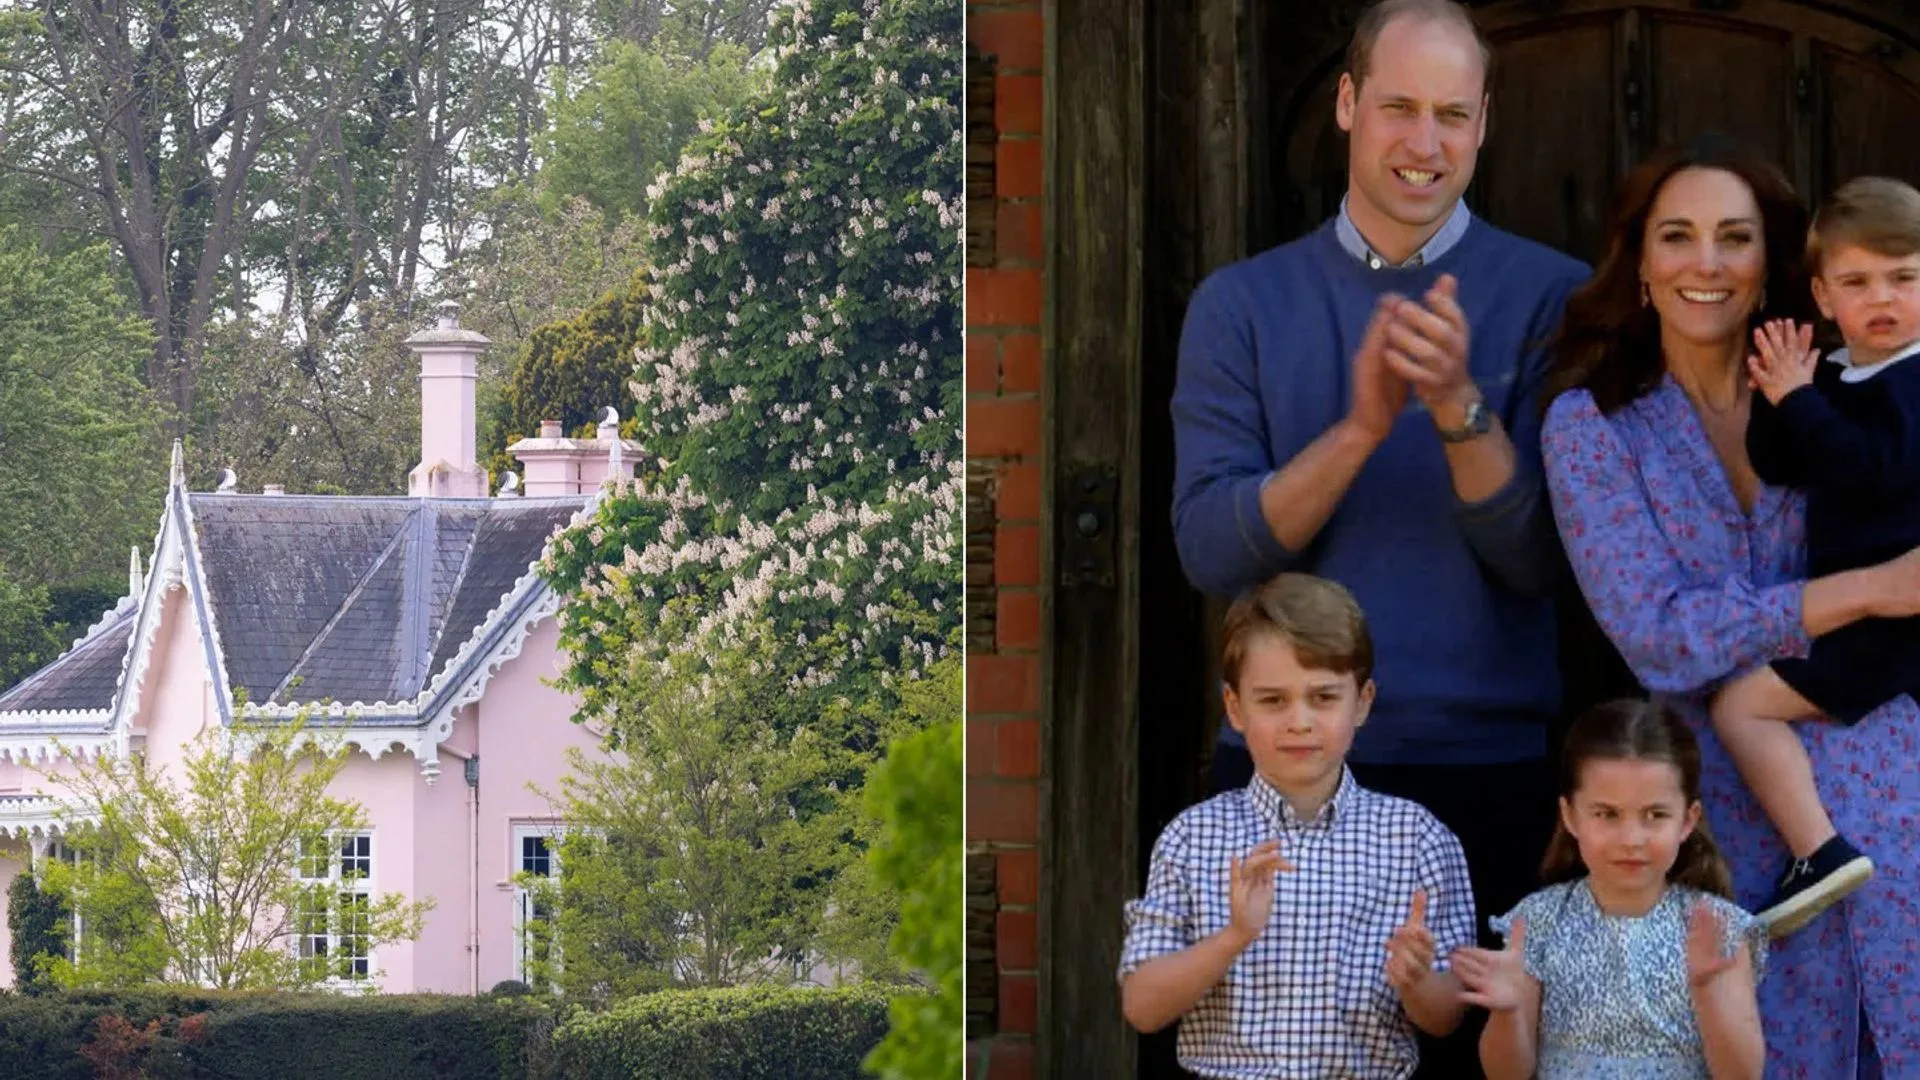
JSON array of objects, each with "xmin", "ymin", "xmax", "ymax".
[{"xmin": 1492, "ymin": 878, "xmax": 1766, "ymax": 1080}]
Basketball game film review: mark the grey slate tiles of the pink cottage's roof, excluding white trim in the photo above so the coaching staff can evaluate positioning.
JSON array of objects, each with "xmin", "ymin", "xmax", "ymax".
[{"xmin": 0, "ymin": 492, "xmax": 588, "ymax": 713}]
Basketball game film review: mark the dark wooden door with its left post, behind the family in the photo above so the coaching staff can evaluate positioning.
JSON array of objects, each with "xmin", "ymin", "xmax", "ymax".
[{"xmin": 1105, "ymin": 0, "xmax": 1920, "ymax": 1078}]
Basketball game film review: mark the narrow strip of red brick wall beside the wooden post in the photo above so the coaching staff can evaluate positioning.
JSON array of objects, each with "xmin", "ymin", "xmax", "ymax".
[{"xmin": 966, "ymin": 0, "xmax": 1046, "ymax": 1080}]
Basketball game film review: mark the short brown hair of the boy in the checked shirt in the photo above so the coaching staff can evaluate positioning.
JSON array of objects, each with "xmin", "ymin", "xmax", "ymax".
[{"xmin": 1221, "ymin": 575, "xmax": 1373, "ymax": 690}]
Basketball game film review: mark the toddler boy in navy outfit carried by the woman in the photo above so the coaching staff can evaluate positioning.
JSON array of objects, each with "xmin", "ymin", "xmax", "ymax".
[{"xmin": 1713, "ymin": 177, "xmax": 1920, "ymax": 936}]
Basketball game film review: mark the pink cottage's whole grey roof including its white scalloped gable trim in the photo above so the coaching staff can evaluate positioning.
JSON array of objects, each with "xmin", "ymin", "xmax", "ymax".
[{"xmin": 0, "ymin": 453, "xmax": 597, "ymax": 759}]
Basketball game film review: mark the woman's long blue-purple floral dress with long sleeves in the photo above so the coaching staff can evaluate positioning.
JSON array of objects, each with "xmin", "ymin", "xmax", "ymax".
[{"xmin": 1542, "ymin": 379, "xmax": 1920, "ymax": 1080}]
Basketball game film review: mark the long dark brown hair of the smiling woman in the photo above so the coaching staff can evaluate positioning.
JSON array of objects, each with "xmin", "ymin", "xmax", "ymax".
[{"xmin": 1540, "ymin": 135, "xmax": 1814, "ymax": 415}]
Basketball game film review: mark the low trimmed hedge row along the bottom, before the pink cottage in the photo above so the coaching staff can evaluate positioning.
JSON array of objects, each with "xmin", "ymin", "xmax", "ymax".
[{"xmin": 0, "ymin": 986, "xmax": 906, "ymax": 1080}]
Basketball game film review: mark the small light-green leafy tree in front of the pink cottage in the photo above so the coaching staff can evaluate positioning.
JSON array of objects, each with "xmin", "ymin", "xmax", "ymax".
[{"xmin": 46, "ymin": 721, "xmax": 430, "ymax": 990}]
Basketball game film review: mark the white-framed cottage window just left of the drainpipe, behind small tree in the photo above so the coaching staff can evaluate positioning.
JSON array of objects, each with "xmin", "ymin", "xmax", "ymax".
[{"xmin": 294, "ymin": 832, "xmax": 372, "ymax": 986}]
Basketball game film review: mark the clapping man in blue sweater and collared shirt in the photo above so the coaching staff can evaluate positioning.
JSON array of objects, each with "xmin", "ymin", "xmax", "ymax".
[{"xmin": 1173, "ymin": 0, "xmax": 1588, "ymax": 1076}]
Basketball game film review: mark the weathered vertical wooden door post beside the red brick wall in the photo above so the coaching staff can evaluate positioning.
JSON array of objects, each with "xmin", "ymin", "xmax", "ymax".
[{"xmin": 1039, "ymin": 0, "xmax": 1146, "ymax": 1078}]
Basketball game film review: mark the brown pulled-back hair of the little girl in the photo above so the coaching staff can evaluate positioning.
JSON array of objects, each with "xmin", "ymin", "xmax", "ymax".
[{"xmin": 1540, "ymin": 700, "xmax": 1734, "ymax": 899}]
